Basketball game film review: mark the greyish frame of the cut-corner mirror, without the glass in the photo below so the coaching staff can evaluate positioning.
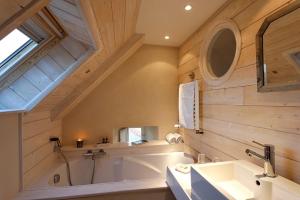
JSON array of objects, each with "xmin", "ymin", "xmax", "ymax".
[{"xmin": 256, "ymin": 2, "xmax": 300, "ymax": 92}]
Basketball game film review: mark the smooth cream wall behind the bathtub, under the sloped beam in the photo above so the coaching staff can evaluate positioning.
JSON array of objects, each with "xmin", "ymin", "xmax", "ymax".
[{"xmin": 62, "ymin": 45, "xmax": 178, "ymax": 145}]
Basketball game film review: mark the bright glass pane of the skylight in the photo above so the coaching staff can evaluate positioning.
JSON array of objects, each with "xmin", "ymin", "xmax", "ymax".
[{"xmin": 0, "ymin": 29, "xmax": 38, "ymax": 76}]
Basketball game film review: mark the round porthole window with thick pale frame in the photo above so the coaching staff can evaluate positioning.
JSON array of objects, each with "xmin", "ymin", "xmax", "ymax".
[{"xmin": 199, "ymin": 20, "xmax": 241, "ymax": 85}]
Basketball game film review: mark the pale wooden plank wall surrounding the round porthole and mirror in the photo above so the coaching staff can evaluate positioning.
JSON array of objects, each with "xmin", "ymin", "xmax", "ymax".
[{"xmin": 178, "ymin": 0, "xmax": 300, "ymax": 183}]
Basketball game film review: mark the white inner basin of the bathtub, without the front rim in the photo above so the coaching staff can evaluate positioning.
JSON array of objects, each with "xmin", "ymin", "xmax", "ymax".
[{"xmin": 35, "ymin": 152, "xmax": 193, "ymax": 188}]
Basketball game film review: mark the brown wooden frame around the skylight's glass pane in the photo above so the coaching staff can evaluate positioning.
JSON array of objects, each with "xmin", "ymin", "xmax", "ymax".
[{"xmin": 0, "ymin": 7, "xmax": 67, "ymax": 83}]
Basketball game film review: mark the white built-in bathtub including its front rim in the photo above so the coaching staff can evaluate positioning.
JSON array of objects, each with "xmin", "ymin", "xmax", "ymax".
[{"xmin": 17, "ymin": 152, "xmax": 194, "ymax": 200}]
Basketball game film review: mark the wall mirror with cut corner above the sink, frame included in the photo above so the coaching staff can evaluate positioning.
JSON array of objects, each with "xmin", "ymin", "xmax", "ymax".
[{"xmin": 257, "ymin": 2, "xmax": 300, "ymax": 92}]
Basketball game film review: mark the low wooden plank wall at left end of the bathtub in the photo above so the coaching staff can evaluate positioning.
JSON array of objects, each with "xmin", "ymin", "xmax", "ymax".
[{"xmin": 22, "ymin": 112, "xmax": 62, "ymax": 188}]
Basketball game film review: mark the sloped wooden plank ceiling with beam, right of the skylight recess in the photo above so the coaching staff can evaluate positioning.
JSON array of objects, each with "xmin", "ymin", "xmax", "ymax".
[{"xmin": 34, "ymin": 0, "xmax": 143, "ymax": 118}]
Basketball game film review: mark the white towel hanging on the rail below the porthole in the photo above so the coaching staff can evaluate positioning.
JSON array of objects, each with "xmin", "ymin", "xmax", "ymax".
[{"xmin": 179, "ymin": 80, "xmax": 199, "ymax": 130}]
